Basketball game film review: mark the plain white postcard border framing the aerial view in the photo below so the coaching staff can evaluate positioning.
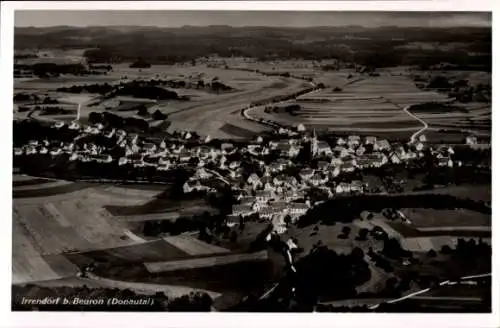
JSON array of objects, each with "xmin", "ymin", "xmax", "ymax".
[{"xmin": 0, "ymin": 0, "xmax": 500, "ymax": 328}]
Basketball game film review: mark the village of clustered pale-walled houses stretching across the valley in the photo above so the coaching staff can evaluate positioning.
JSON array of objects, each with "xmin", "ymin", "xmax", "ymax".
[{"xmin": 14, "ymin": 116, "xmax": 484, "ymax": 234}]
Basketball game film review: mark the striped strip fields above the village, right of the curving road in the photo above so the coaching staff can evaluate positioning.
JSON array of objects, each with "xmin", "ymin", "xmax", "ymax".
[{"xmin": 253, "ymin": 73, "xmax": 454, "ymax": 136}]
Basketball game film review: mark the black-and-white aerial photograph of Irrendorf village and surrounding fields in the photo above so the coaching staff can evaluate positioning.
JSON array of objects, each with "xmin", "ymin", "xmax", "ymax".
[{"xmin": 9, "ymin": 10, "xmax": 492, "ymax": 313}]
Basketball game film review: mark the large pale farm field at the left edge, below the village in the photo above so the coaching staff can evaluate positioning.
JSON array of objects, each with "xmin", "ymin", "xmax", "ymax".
[{"xmin": 12, "ymin": 175, "xmax": 172, "ymax": 282}]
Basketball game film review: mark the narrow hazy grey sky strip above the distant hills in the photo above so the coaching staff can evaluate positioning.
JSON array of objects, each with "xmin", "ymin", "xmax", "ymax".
[{"xmin": 15, "ymin": 10, "xmax": 491, "ymax": 27}]
